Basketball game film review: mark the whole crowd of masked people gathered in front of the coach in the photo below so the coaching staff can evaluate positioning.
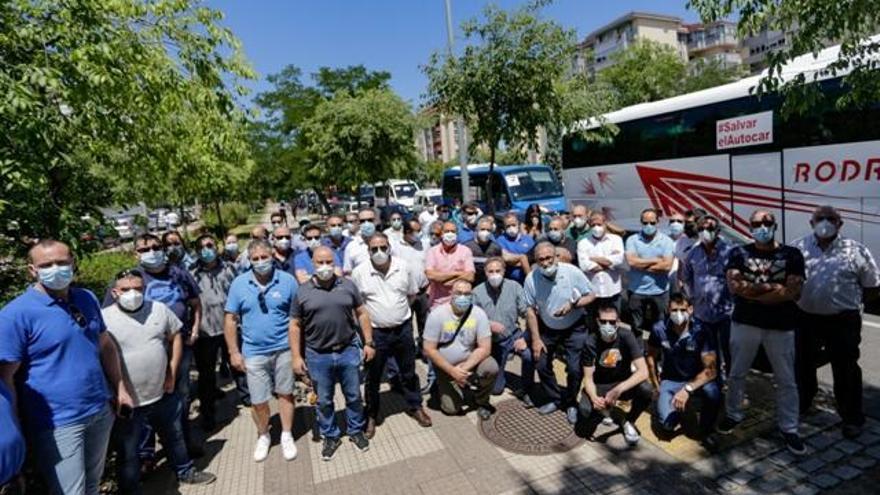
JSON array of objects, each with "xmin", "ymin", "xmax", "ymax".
[{"xmin": 0, "ymin": 204, "xmax": 880, "ymax": 495}]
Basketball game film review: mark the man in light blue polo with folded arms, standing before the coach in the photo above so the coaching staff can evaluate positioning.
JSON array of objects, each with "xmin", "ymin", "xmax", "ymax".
[{"xmin": 624, "ymin": 208, "xmax": 675, "ymax": 335}]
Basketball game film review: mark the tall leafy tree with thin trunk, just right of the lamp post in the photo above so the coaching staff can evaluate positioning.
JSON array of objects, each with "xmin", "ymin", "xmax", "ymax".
[{"xmin": 424, "ymin": 2, "xmax": 586, "ymax": 212}]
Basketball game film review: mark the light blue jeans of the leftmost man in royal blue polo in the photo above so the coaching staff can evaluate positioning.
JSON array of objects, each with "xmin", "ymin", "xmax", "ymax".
[{"xmin": 31, "ymin": 405, "xmax": 114, "ymax": 495}]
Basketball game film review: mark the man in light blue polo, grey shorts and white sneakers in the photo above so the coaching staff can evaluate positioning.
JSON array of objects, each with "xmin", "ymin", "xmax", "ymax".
[{"xmin": 224, "ymin": 240, "xmax": 299, "ymax": 462}]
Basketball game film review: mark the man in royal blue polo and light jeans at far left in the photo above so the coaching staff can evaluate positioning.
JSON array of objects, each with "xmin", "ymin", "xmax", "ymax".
[{"xmin": 0, "ymin": 240, "xmax": 134, "ymax": 494}]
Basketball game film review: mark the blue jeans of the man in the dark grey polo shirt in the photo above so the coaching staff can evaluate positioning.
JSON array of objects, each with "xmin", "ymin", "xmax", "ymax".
[{"xmin": 306, "ymin": 343, "xmax": 366, "ymax": 438}]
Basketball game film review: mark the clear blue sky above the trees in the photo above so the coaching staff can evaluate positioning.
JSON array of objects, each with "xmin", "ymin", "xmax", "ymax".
[{"xmin": 206, "ymin": 0, "xmax": 697, "ymax": 105}]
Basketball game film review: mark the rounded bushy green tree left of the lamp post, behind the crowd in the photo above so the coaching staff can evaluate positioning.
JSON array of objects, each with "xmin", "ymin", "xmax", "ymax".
[{"xmin": 301, "ymin": 89, "xmax": 415, "ymax": 200}]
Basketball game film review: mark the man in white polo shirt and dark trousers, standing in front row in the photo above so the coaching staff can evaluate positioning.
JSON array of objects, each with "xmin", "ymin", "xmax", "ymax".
[{"xmin": 351, "ymin": 232, "xmax": 431, "ymax": 439}]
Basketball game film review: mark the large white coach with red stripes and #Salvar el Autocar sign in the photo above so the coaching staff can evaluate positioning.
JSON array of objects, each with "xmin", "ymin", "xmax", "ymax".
[{"xmin": 562, "ymin": 37, "xmax": 880, "ymax": 255}]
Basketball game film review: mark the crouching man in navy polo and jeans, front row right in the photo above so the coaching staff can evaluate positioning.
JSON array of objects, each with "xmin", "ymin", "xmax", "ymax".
[{"xmin": 647, "ymin": 293, "xmax": 721, "ymax": 437}]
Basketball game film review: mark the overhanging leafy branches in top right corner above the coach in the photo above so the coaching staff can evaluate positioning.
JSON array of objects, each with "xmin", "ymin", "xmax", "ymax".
[{"xmin": 689, "ymin": 0, "xmax": 880, "ymax": 113}]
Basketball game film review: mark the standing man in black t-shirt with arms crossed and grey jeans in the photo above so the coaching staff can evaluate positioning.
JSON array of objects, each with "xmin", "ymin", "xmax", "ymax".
[{"xmin": 718, "ymin": 210, "xmax": 806, "ymax": 455}]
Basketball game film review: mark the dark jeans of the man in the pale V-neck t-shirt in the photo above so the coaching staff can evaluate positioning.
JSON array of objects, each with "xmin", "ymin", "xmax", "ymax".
[{"xmin": 113, "ymin": 394, "xmax": 193, "ymax": 494}]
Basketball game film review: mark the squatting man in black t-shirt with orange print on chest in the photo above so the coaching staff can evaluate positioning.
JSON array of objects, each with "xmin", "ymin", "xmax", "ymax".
[{"xmin": 578, "ymin": 305, "xmax": 653, "ymax": 445}]
